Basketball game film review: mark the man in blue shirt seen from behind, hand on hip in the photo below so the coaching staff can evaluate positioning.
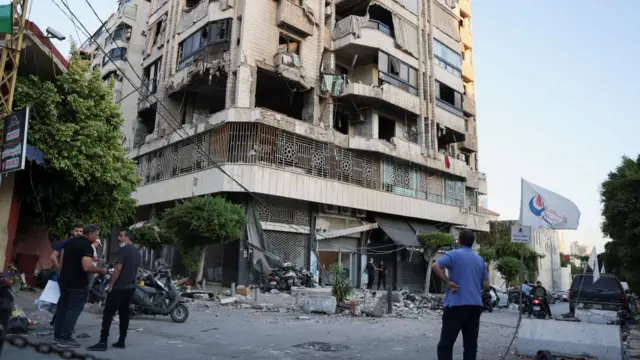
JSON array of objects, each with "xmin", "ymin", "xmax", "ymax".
[{"xmin": 431, "ymin": 229, "xmax": 490, "ymax": 360}]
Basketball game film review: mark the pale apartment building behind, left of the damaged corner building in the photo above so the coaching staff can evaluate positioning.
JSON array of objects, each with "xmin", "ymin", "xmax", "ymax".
[{"xmin": 80, "ymin": 0, "xmax": 151, "ymax": 148}]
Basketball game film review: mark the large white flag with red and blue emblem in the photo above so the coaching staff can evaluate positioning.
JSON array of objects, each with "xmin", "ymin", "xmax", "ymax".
[{"xmin": 520, "ymin": 179, "xmax": 580, "ymax": 230}]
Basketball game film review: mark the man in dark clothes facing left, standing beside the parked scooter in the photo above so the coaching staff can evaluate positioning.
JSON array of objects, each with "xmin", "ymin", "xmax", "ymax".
[{"xmin": 87, "ymin": 230, "xmax": 141, "ymax": 351}]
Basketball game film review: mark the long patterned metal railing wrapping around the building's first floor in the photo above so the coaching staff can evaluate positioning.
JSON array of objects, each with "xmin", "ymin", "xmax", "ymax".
[{"xmin": 136, "ymin": 123, "xmax": 465, "ymax": 206}]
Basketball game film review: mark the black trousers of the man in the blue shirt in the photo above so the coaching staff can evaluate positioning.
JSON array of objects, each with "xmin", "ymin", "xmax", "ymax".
[{"xmin": 438, "ymin": 305, "xmax": 484, "ymax": 360}]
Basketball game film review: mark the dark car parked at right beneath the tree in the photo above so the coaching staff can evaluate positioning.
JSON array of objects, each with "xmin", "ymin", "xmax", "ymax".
[{"xmin": 569, "ymin": 273, "xmax": 629, "ymax": 313}]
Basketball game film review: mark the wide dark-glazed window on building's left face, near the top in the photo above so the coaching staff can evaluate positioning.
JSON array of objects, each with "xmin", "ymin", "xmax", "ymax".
[{"xmin": 178, "ymin": 19, "xmax": 231, "ymax": 69}]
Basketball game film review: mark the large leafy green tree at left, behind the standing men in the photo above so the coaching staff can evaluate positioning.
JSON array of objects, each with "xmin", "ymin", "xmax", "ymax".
[{"xmin": 15, "ymin": 51, "xmax": 138, "ymax": 236}]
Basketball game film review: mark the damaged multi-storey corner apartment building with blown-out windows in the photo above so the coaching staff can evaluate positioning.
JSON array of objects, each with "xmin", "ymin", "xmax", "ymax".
[{"xmin": 92, "ymin": 0, "xmax": 489, "ymax": 288}]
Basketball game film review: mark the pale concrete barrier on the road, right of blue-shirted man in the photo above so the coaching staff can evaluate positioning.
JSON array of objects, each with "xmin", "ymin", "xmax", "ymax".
[{"xmin": 513, "ymin": 319, "xmax": 622, "ymax": 360}]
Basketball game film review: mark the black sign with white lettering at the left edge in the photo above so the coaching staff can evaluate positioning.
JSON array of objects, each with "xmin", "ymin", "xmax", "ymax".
[{"xmin": 0, "ymin": 108, "xmax": 29, "ymax": 174}]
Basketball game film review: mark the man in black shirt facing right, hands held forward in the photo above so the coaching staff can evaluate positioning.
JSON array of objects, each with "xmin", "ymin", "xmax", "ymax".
[{"xmin": 53, "ymin": 224, "xmax": 106, "ymax": 348}]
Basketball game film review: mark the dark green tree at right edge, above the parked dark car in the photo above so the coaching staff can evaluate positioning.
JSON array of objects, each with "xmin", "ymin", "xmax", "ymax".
[{"xmin": 599, "ymin": 155, "xmax": 640, "ymax": 292}]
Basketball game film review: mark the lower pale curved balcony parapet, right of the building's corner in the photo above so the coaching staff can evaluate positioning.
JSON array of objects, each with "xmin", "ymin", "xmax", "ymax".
[{"xmin": 339, "ymin": 82, "xmax": 420, "ymax": 115}]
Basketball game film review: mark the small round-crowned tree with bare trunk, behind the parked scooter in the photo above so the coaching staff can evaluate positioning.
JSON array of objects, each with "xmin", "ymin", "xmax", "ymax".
[{"xmin": 159, "ymin": 196, "xmax": 246, "ymax": 281}]
